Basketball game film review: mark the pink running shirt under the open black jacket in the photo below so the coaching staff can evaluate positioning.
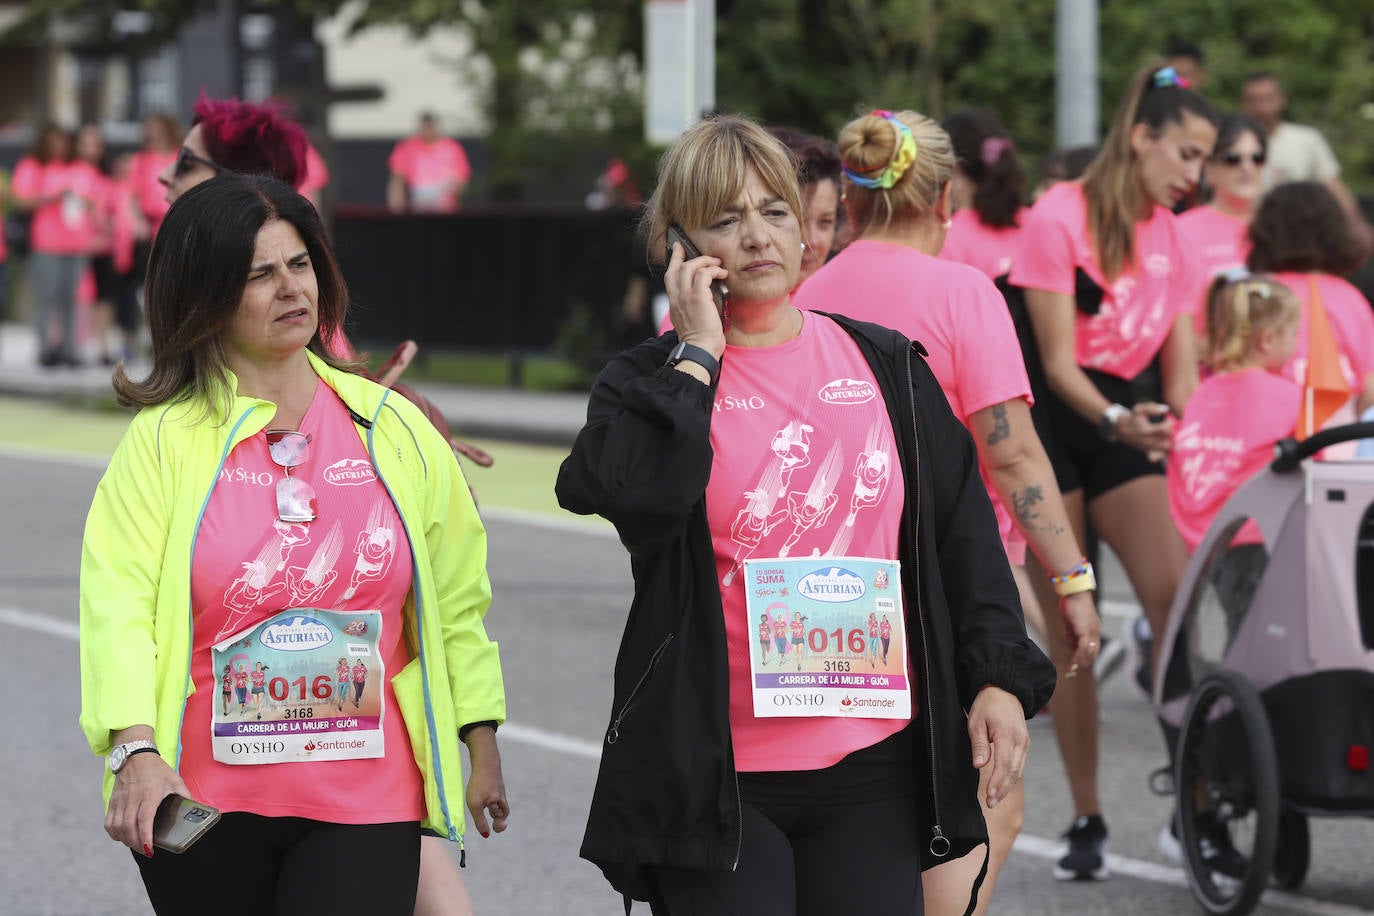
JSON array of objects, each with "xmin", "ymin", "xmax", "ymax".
[{"xmin": 706, "ymin": 314, "xmax": 918, "ymax": 772}]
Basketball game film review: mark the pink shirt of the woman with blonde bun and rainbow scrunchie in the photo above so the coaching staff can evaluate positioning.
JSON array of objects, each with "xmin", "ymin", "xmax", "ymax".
[{"xmin": 794, "ymin": 239, "xmax": 1032, "ymax": 566}]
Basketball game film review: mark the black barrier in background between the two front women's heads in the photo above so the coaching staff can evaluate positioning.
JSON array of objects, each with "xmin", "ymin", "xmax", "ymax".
[{"xmin": 334, "ymin": 207, "xmax": 636, "ymax": 354}]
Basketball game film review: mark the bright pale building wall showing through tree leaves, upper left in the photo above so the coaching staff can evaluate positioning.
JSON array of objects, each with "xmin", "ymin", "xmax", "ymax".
[{"xmin": 315, "ymin": 3, "xmax": 486, "ymax": 140}]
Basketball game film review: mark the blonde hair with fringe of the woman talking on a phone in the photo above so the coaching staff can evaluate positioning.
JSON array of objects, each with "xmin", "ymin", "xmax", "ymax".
[{"xmin": 640, "ymin": 114, "xmax": 804, "ymax": 264}]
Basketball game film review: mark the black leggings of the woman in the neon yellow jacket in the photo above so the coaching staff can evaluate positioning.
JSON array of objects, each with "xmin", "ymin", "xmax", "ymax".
[{"xmin": 133, "ymin": 812, "xmax": 420, "ymax": 916}]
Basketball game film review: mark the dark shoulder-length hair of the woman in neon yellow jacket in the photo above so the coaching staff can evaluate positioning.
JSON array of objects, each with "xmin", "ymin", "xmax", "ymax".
[{"xmin": 114, "ymin": 174, "xmax": 356, "ymax": 417}]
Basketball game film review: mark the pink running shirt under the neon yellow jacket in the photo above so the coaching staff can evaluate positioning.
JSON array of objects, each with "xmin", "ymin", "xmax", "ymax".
[{"xmin": 181, "ymin": 382, "xmax": 425, "ymax": 824}]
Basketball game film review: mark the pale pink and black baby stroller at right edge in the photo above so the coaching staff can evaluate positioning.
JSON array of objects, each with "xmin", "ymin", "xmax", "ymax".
[{"xmin": 1154, "ymin": 423, "xmax": 1374, "ymax": 915}]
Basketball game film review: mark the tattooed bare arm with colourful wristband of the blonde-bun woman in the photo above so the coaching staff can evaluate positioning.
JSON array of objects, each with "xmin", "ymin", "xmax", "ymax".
[{"xmin": 969, "ymin": 398, "xmax": 1101, "ymax": 673}]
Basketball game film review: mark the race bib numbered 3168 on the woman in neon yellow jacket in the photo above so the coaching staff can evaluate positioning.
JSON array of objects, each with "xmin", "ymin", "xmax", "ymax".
[{"xmin": 210, "ymin": 608, "xmax": 386, "ymax": 764}]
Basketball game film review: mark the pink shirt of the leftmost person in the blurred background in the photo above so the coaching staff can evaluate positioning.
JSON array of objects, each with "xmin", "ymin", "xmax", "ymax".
[{"xmin": 11, "ymin": 158, "xmax": 104, "ymax": 254}]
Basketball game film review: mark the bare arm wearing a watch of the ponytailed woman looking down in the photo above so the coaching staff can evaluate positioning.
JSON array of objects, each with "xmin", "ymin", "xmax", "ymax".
[{"xmin": 1025, "ymin": 288, "xmax": 1176, "ymax": 453}]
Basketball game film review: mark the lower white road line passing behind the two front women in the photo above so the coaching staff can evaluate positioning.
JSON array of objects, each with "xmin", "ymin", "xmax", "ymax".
[{"xmin": 0, "ymin": 607, "xmax": 1374, "ymax": 916}]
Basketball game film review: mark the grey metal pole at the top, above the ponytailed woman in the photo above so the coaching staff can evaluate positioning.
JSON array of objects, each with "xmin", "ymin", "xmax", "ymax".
[{"xmin": 1054, "ymin": 0, "xmax": 1098, "ymax": 148}]
